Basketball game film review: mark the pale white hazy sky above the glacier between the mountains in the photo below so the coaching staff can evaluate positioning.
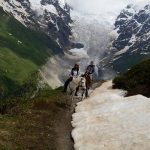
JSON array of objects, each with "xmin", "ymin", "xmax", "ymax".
[{"xmin": 66, "ymin": 0, "xmax": 150, "ymax": 14}]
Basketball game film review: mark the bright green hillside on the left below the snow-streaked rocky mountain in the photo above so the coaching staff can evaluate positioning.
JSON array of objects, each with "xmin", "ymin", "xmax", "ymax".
[{"xmin": 0, "ymin": 8, "xmax": 62, "ymax": 97}]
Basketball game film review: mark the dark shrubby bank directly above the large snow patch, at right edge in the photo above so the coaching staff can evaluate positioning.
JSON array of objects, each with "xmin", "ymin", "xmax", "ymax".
[{"xmin": 113, "ymin": 60, "xmax": 150, "ymax": 94}]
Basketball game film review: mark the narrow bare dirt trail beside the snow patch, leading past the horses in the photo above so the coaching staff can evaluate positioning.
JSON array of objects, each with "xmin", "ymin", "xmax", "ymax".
[{"xmin": 52, "ymin": 82, "xmax": 101, "ymax": 150}]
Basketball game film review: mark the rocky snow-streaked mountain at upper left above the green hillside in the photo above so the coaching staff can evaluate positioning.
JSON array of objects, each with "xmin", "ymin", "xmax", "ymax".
[{"xmin": 0, "ymin": 0, "xmax": 83, "ymax": 50}]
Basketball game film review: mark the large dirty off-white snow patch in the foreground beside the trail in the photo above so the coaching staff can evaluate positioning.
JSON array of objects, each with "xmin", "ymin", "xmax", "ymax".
[{"xmin": 72, "ymin": 81, "xmax": 150, "ymax": 150}]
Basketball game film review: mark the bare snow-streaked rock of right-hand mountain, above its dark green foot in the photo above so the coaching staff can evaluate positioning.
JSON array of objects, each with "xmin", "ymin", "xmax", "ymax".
[{"xmin": 113, "ymin": 5, "xmax": 150, "ymax": 53}]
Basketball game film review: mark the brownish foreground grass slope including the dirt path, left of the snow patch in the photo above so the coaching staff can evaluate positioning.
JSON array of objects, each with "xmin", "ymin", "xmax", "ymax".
[{"xmin": 0, "ymin": 88, "xmax": 73, "ymax": 150}]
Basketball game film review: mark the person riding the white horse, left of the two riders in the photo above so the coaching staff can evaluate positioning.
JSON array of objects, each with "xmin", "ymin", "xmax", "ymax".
[{"xmin": 63, "ymin": 64, "xmax": 80, "ymax": 94}]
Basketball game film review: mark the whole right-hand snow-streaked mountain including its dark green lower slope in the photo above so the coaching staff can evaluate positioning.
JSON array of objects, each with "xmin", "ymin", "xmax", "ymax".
[{"xmin": 100, "ymin": 5, "xmax": 150, "ymax": 72}]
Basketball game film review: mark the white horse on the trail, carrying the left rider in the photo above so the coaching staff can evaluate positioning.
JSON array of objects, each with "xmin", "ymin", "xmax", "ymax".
[{"xmin": 67, "ymin": 77, "xmax": 86, "ymax": 100}]
